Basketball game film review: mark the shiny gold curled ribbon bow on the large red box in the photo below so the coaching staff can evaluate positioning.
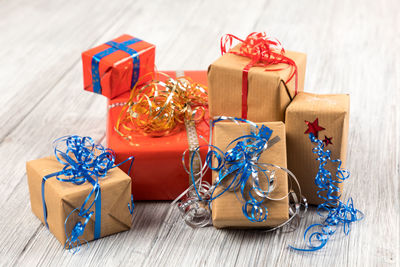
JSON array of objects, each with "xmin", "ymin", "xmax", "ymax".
[{"xmin": 115, "ymin": 72, "xmax": 208, "ymax": 138}]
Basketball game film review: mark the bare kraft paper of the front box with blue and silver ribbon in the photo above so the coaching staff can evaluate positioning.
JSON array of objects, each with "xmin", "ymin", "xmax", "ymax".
[{"xmin": 212, "ymin": 122, "xmax": 289, "ymax": 228}]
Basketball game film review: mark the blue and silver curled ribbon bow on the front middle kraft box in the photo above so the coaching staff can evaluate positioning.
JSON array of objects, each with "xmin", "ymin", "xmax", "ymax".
[{"xmin": 172, "ymin": 117, "xmax": 307, "ymax": 230}]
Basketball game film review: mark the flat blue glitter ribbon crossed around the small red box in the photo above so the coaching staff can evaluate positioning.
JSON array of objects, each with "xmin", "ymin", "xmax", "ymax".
[{"xmin": 92, "ymin": 38, "xmax": 141, "ymax": 94}]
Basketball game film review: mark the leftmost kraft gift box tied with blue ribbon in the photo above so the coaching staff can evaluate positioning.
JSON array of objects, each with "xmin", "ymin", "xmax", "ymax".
[{"xmin": 26, "ymin": 138, "xmax": 133, "ymax": 248}]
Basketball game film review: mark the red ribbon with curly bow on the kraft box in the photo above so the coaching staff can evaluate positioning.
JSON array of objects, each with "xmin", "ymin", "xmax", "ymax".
[{"xmin": 221, "ymin": 32, "xmax": 297, "ymax": 119}]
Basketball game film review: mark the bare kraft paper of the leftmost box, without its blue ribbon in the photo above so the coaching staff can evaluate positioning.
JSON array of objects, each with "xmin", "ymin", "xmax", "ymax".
[{"xmin": 26, "ymin": 156, "xmax": 132, "ymax": 245}]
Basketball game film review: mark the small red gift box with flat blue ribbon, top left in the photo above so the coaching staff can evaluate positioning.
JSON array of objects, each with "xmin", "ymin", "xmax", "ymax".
[{"xmin": 82, "ymin": 34, "xmax": 155, "ymax": 99}]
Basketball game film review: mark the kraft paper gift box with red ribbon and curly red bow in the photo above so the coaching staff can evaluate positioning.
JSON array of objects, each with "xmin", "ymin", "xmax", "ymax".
[{"xmin": 208, "ymin": 33, "xmax": 306, "ymax": 122}]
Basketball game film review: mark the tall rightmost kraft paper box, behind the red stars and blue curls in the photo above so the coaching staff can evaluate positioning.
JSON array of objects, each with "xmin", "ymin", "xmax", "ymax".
[{"xmin": 286, "ymin": 93, "xmax": 350, "ymax": 205}]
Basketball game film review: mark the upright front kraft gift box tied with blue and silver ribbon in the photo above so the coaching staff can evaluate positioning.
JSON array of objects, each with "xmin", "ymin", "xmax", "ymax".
[{"xmin": 212, "ymin": 122, "xmax": 289, "ymax": 228}]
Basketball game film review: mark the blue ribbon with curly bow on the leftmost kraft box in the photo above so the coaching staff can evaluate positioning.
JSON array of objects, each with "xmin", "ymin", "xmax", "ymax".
[{"xmin": 42, "ymin": 135, "xmax": 134, "ymax": 253}]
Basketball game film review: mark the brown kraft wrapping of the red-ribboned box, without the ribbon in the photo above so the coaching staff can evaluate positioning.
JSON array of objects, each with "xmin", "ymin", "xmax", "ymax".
[{"xmin": 208, "ymin": 48, "xmax": 306, "ymax": 122}]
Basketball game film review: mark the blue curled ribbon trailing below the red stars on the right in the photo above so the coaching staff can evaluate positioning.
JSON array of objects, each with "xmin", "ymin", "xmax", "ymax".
[{"xmin": 289, "ymin": 133, "xmax": 364, "ymax": 251}]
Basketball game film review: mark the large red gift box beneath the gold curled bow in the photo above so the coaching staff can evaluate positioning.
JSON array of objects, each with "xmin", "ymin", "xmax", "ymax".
[{"xmin": 107, "ymin": 71, "xmax": 211, "ymax": 200}]
